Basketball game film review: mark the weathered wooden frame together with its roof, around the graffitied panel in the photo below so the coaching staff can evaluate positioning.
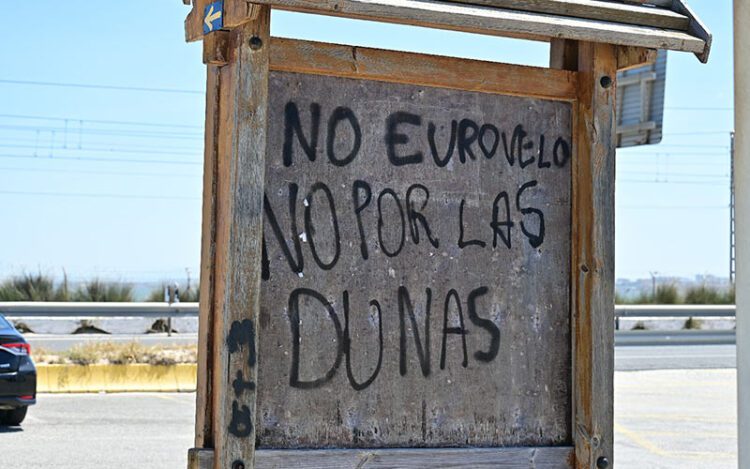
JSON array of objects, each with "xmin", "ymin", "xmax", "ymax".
[{"xmin": 172, "ymin": 0, "xmax": 711, "ymax": 460}]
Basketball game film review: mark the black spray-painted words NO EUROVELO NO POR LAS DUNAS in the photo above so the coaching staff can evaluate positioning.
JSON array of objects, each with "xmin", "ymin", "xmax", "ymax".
[{"xmin": 264, "ymin": 101, "xmax": 572, "ymax": 394}]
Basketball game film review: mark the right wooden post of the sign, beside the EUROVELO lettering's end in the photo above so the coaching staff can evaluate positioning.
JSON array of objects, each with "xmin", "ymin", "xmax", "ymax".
[{"xmin": 550, "ymin": 41, "xmax": 617, "ymax": 469}]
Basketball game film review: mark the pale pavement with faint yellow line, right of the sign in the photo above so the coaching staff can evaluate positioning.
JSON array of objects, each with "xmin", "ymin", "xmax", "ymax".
[{"xmin": 615, "ymin": 369, "xmax": 737, "ymax": 469}]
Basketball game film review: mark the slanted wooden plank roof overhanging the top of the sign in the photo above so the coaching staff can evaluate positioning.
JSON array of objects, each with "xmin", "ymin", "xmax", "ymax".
[{"xmin": 185, "ymin": 0, "xmax": 711, "ymax": 62}]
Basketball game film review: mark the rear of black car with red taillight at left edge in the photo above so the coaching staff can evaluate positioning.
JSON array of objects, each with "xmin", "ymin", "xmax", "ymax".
[{"xmin": 0, "ymin": 314, "xmax": 36, "ymax": 425}]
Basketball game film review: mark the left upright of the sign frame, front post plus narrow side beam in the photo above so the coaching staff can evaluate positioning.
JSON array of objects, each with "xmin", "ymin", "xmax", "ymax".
[{"xmin": 190, "ymin": 8, "xmax": 270, "ymax": 468}]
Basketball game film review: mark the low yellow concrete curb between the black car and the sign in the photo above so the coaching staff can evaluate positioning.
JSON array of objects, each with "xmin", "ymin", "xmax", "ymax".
[{"xmin": 37, "ymin": 363, "xmax": 197, "ymax": 393}]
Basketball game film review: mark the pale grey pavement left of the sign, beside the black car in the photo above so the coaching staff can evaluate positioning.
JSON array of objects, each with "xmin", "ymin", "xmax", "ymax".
[{"xmin": 0, "ymin": 393, "xmax": 195, "ymax": 469}]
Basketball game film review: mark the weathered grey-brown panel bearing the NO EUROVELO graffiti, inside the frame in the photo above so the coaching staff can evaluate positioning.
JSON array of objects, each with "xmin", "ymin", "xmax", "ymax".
[{"xmin": 257, "ymin": 69, "xmax": 572, "ymax": 448}]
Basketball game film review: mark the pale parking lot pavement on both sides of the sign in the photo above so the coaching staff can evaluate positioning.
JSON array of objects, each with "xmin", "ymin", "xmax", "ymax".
[{"xmin": 0, "ymin": 369, "xmax": 737, "ymax": 469}]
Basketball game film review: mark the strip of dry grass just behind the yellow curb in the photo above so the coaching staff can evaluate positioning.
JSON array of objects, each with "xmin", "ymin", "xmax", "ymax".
[{"xmin": 32, "ymin": 342, "xmax": 198, "ymax": 365}]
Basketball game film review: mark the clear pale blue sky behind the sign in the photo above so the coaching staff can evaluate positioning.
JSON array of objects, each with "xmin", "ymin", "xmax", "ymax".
[{"xmin": 0, "ymin": 0, "xmax": 733, "ymax": 281}]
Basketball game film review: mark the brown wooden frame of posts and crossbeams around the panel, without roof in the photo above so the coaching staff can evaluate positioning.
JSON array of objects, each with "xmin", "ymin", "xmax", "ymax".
[{"xmin": 190, "ymin": 24, "xmax": 618, "ymax": 469}]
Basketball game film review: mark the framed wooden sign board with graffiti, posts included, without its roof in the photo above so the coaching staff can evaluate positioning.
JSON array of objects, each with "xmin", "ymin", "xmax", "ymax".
[{"xmin": 191, "ymin": 8, "xmax": 617, "ymax": 469}]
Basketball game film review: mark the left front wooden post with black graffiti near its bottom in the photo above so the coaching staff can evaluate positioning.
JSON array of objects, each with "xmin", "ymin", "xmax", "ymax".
[{"xmin": 209, "ymin": 7, "xmax": 270, "ymax": 469}]
